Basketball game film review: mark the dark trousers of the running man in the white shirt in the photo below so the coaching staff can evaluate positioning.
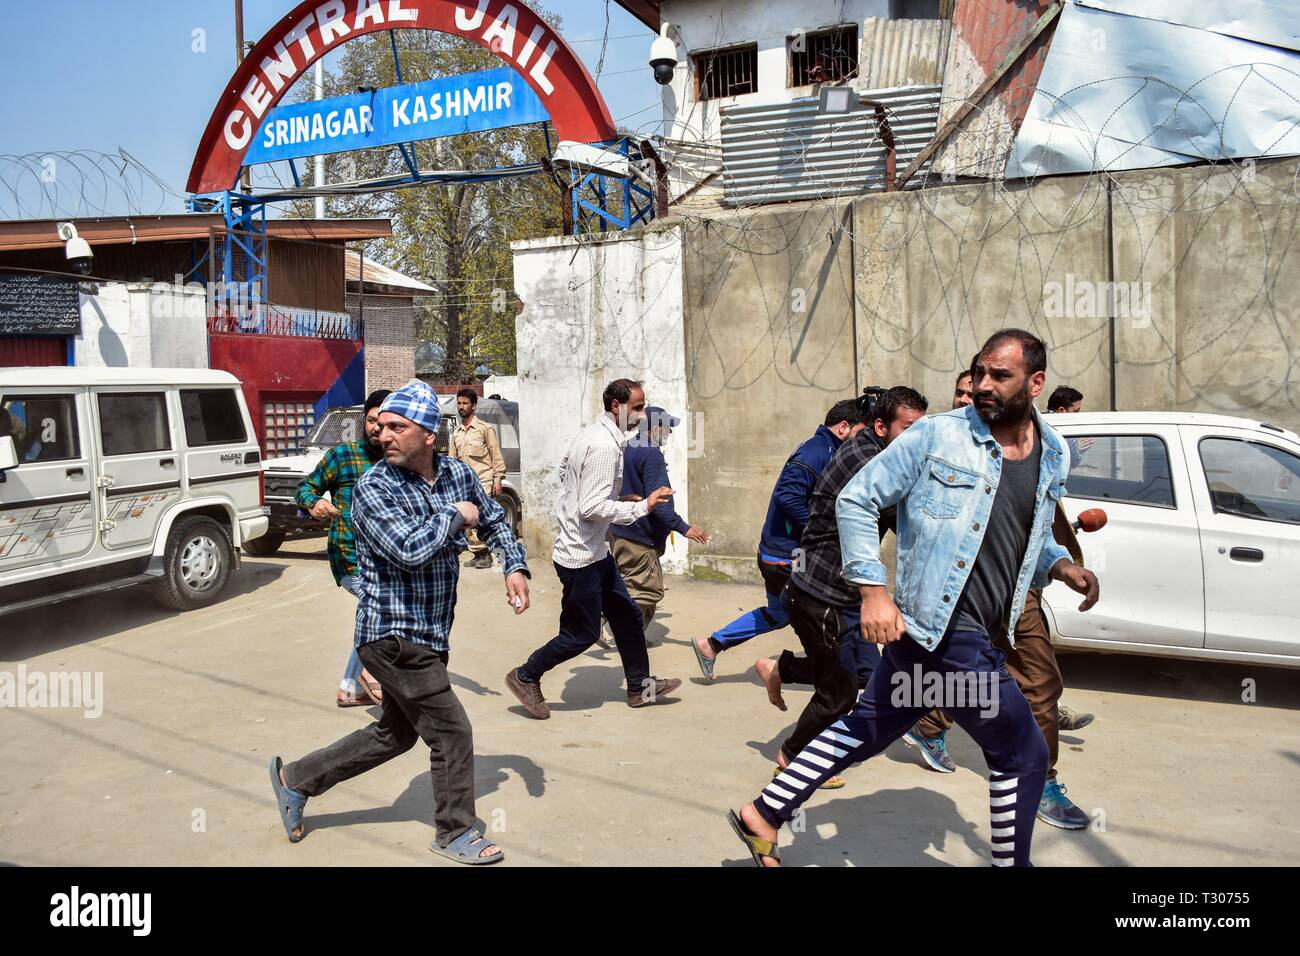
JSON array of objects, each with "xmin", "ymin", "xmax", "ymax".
[{"xmin": 517, "ymin": 554, "xmax": 650, "ymax": 691}]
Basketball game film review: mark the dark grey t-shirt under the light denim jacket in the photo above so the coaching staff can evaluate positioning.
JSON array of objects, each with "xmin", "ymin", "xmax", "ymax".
[{"xmin": 949, "ymin": 429, "xmax": 1043, "ymax": 639}]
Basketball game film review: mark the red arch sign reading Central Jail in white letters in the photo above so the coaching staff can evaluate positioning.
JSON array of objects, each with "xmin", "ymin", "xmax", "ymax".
[{"xmin": 186, "ymin": 0, "xmax": 616, "ymax": 193}]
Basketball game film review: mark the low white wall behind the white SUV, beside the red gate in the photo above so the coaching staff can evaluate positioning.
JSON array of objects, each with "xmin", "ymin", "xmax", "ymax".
[{"xmin": 73, "ymin": 282, "xmax": 208, "ymax": 368}]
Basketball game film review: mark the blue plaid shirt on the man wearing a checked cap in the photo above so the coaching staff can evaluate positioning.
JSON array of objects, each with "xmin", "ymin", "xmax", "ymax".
[{"xmin": 352, "ymin": 455, "xmax": 532, "ymax": 652}]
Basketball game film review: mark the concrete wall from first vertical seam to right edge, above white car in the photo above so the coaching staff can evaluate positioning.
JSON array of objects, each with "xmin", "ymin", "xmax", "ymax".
[{"xmin": 854, "ymin": 160, "xmax": 1300, "ymax": 429}]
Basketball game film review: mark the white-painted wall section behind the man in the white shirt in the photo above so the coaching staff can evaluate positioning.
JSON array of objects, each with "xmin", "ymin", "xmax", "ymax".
[{"xmin": 503, "ymin": 226, "xmax": 694, "ymax": 574}]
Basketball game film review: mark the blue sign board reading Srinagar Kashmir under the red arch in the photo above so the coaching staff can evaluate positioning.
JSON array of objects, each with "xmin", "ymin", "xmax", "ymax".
[{"xmin": 244, "ymin": 66, "xmax": 549, "ymax": 165}]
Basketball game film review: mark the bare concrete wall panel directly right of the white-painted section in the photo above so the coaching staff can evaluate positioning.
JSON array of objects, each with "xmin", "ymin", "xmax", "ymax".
[{"xmin": 684, "ymin": 202, "xmax": 858, "ymax": 579}]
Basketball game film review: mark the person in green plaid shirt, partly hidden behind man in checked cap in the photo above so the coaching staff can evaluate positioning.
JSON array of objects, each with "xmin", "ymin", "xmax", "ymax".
[{"xmin": 294, "ymin": 389, "xmax": 389, "ymax": 708}]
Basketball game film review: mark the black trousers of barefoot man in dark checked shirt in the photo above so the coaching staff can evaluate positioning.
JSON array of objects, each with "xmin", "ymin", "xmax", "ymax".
[{"xmin": 781, "ymin": 584, "xmax": 880, "ymax": 761}]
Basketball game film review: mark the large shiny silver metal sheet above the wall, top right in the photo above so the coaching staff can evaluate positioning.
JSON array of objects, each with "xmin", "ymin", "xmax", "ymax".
[{"xmin": 1005, "ymin": 0, "xmax": 1300, "ymax": 179}]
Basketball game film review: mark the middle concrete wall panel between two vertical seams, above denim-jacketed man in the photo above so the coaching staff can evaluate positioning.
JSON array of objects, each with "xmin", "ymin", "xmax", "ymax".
[{"xmin": 854, "ymin": 170, "xmax": 1110, "ymax": 408}]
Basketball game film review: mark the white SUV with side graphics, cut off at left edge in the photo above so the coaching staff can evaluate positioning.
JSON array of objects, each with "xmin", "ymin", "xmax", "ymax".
[{"xmin": 0, "ymin": 368, "xmax": 267, "ymax": 614}]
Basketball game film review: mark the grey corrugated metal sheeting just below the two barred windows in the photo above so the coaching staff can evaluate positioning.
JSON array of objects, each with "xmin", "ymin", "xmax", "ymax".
[{"xmin": 722, "ymin": 85, "xmax": 940, "ymax": 206}]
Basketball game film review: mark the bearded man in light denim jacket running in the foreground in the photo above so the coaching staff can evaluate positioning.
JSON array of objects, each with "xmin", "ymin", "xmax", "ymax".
[{"xmin": 728, "ymin": 329, "xmax": 1099, "ymax": 866}]
